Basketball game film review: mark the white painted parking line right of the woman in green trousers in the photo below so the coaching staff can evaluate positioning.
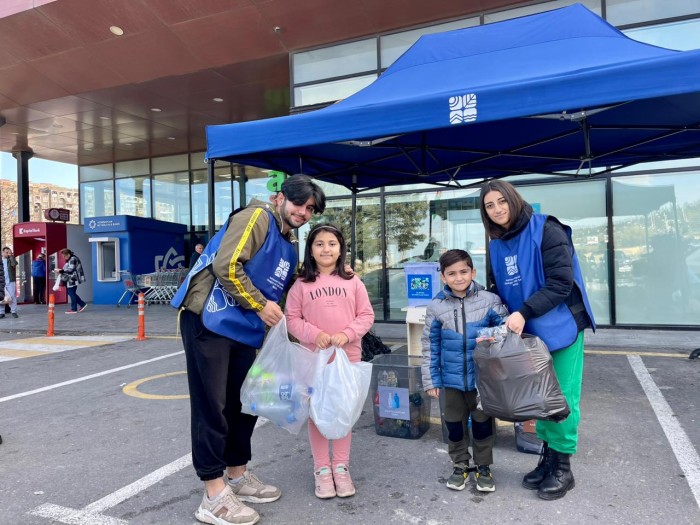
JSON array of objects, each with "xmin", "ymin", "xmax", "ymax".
[{"xmin": 627, "ymin": 355, "xmax": 700, "ymax": 507}]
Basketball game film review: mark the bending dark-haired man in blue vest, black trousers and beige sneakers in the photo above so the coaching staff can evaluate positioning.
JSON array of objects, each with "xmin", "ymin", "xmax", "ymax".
[{"xmin": 171, "ymin": 175, "xmax": 326, "ymax": 525}]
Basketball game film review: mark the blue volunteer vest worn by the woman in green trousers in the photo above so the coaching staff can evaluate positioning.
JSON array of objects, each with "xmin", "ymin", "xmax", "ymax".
[{"xmin": 489, "ymin": 214, "xmax": 595, "ymax": 351}]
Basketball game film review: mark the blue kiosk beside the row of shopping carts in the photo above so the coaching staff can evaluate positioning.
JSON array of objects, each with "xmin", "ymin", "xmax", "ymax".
[{"xmin": 85, "ymin": 215, "xmax": 187, "ymax": 304}]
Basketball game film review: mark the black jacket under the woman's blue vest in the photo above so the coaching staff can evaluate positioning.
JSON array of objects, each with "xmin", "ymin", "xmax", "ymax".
[{"xmin": 489, "ymin": 204, "xmax": 592, "ymax": 331}]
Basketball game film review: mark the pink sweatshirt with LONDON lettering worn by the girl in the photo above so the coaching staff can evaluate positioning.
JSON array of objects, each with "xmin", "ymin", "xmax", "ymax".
[{"xmin": 285, "ymin": 275, "xmax": 374, "ymax": 362}]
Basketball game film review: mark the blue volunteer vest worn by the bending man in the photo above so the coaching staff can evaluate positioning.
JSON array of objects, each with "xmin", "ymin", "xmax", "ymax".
[{"xmin": 170, "ymin": 208, "xmax": 298, "ymax": 348}]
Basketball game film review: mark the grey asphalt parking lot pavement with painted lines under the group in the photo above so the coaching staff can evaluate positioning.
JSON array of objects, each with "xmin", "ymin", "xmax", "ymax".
[{"xmin": 0, "ymin": 304, "xmax": 700, "ymax": 525}]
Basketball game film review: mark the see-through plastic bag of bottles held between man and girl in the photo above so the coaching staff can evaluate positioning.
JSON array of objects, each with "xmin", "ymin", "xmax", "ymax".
[{"xmin": 241, "ymin": 317, "xmax": 332, "ymax": 435}]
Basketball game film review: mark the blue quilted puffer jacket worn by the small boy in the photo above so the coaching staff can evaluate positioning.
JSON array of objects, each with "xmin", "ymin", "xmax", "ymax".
[{"xmin": 421, "ymin": 281, "xmax": 508, "ymax": 391}]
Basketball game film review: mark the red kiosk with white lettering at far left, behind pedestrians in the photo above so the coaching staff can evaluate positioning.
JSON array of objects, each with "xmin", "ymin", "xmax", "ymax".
[{"xmin": 12, "ymin": 222, "xmax": 92, "ymax": 304}]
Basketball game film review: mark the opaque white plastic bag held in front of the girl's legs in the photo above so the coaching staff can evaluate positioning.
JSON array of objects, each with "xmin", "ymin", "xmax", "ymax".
[{"xmin": 310, "ymin": 347, "xmax": 372, "ymax": 439}]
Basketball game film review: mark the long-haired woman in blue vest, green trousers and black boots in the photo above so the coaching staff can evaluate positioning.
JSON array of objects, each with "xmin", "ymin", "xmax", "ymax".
[{"xmin": 481, "ymin": 180, "xmax": 595, "ymax": 500}]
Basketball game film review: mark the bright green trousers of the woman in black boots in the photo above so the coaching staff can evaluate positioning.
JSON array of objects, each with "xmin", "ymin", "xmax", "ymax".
[{"xmin": 535, "ymin": 332, "xmax": 583, "ymax": 454}]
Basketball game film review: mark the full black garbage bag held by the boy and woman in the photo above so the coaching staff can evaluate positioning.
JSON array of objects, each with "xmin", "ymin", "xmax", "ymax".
[{"xmin": 474, "ymin": 330, "xmax": 570, "ymax": 421}]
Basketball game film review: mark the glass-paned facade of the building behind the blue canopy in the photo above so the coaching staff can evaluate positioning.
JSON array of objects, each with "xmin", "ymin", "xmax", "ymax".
[{"xmin": 64, "ymin": 0, "xmax": 700, "ymax": 328}]
